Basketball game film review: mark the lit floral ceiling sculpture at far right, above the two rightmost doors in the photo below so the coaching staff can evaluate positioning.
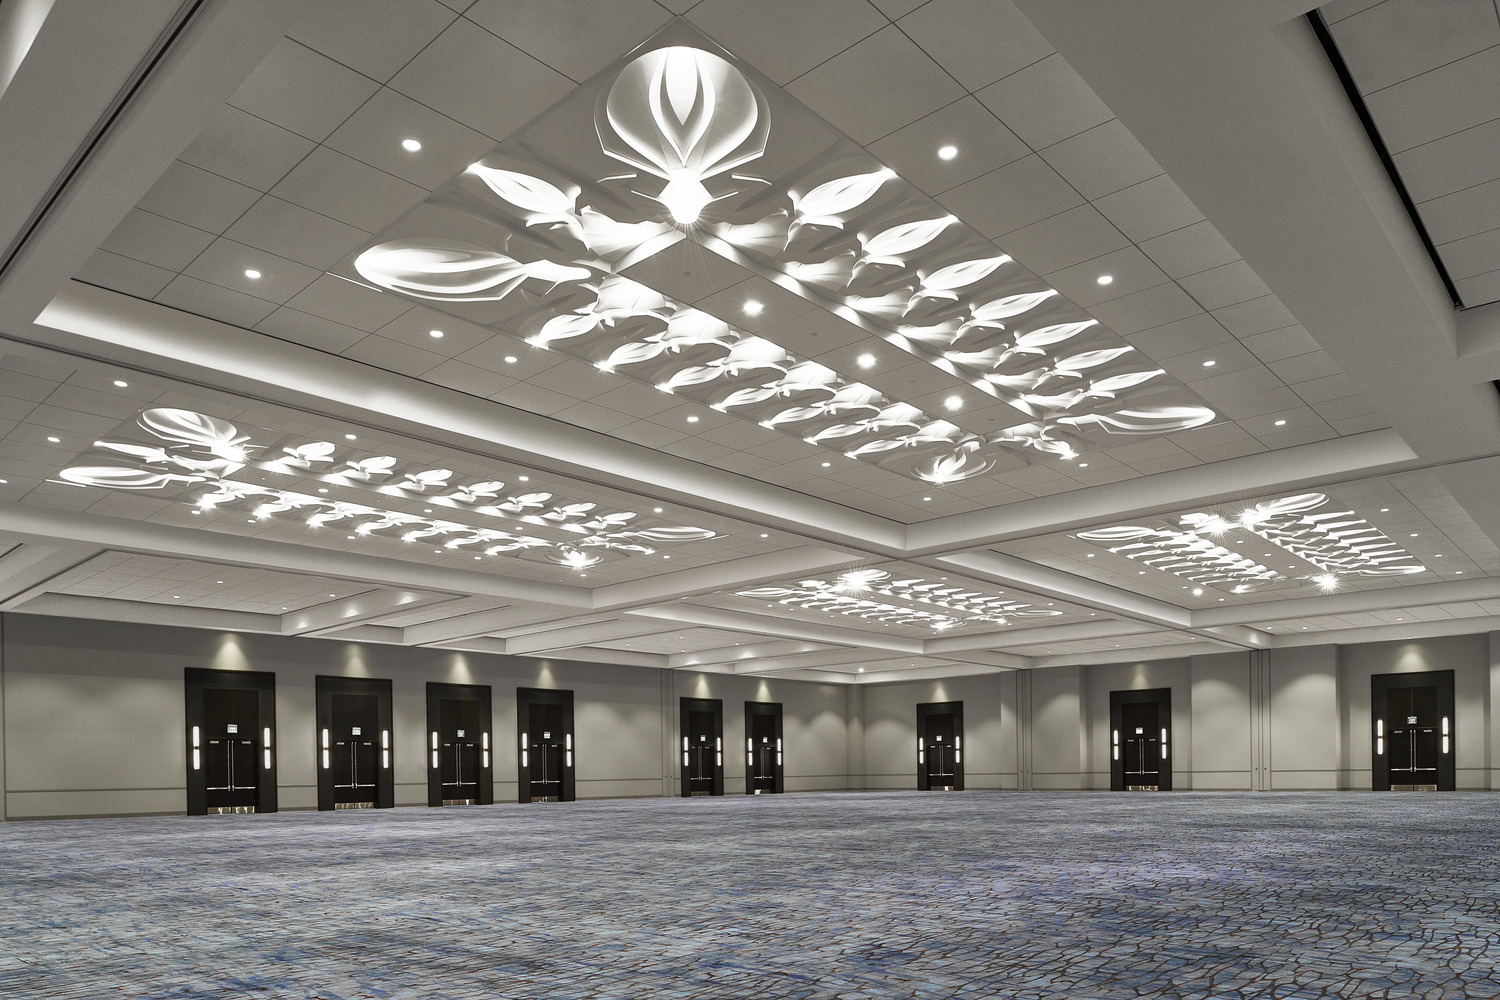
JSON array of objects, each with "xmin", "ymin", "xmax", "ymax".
[{"xmin": 1076, "ymin": 493, "xmax": 1427, "ymax": 594}]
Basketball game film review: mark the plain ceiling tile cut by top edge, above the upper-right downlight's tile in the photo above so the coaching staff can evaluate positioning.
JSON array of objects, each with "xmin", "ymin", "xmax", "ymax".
[{"xmin": 899, "ymin": 0, "xmax": 1053, "ymax": 90}]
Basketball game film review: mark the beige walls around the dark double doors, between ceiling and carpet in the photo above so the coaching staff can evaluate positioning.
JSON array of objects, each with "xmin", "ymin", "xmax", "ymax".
[{"xmin": 0, "ymin": 615, "xmax": 1500, "ymax": 819}]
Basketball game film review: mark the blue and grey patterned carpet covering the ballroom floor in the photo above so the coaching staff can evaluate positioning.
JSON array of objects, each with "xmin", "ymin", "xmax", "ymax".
[{"xmin": 0, "ymin": 792, "xmax": 1500, "ymax": 1000}]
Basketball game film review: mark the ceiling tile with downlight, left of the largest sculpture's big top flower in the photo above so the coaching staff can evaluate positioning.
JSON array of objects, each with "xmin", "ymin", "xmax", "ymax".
[{"xmin": 326, "ymin": 87, "xmax": 495, "ymax": 190}]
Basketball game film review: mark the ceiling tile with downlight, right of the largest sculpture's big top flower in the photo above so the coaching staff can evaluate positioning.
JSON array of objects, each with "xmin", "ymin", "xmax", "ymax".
[{"xmin": 870, "ymin": 96, "xmax": 1031, "ymax": 195}]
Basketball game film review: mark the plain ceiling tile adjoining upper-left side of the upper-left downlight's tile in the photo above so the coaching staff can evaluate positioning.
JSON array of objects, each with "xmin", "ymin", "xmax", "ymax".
[{"xmin": 230, "ymin": 39, "xmax": 380, "ymax": 142}]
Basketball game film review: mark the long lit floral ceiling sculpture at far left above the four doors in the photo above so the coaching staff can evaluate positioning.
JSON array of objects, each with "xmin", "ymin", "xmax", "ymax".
[{"xmin": 59, "ymin": 406, "xmax": 716, "ymax": 570}]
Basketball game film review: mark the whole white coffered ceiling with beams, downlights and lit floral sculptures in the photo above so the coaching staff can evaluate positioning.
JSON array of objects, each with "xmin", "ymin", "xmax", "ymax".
[{"xmin": 0, "ymin": 0, "xmax": 1500, "ymax": 684}]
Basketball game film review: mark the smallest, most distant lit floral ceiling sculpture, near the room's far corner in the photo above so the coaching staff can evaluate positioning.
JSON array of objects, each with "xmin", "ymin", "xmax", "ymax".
[{"xmin": 737, "ymin": 570, "xmax": 1062, "ymax": 631}]
